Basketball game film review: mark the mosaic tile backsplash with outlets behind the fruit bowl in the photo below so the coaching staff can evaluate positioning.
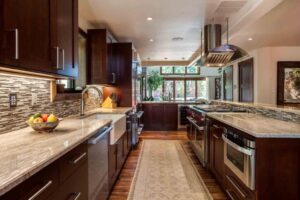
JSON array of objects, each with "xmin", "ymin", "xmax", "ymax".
[{"xmin": 0, "ymin": 75, "xmax": 97, "ymax": 134}]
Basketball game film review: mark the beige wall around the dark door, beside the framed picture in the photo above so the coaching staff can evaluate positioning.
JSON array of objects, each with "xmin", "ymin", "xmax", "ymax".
[{"xmin": 226, "ymin": 47, "xmax": 300, "ymax": 105}]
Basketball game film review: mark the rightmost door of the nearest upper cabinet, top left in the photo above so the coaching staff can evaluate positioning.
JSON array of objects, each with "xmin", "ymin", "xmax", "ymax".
[{"xmin": 51, "ymin": 0, "xmax": 78, "ymax": 77}]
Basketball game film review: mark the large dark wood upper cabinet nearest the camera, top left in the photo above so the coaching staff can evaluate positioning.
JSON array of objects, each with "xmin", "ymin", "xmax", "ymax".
[{"xmin": 0, "ymin": 0, "xmax": 78, "ymax": 77}]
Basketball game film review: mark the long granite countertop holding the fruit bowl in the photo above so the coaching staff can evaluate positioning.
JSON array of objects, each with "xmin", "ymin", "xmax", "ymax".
[{"xmin": 0, "ymin": 115, "xmax": 112, "ymax": 195}]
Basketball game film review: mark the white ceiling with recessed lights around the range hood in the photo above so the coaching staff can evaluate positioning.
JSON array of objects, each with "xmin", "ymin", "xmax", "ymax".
[{"xmin": 79, "ymin": 0, "xmax": 300, "ymax": 61}]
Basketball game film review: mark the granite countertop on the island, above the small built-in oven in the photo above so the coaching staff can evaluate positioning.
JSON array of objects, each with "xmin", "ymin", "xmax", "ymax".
[{"xmin": 207, "ymin": 113, "xmax": 300, "ymax": 138}]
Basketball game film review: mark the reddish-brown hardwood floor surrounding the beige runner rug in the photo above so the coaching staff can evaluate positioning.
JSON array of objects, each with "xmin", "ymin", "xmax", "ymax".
[{"xmin": 109, "ymin": 131, "xmax": 227, "ymax": 200}]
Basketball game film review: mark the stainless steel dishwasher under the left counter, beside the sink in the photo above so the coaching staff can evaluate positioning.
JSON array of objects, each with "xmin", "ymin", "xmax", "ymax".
[{"xmin": 88, "ymin": 126, "xmax": 113, "ymax": 200}]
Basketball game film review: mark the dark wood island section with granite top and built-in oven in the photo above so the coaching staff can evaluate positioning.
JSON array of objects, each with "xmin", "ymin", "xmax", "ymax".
[{"xmin": 207, "ymin": 113, "xmax": 300, "ymax": 200}]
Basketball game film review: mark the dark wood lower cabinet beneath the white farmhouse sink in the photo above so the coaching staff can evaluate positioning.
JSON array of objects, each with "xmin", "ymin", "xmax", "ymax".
[{"xmin": 108, "ymin": 132, "xmax": 131, "ymax": 190}]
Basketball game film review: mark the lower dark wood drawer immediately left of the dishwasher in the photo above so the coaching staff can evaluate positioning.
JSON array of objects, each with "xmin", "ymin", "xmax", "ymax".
[{"xmin": 57, "ymin": 162, "xmax": 88, "ymax": 200}]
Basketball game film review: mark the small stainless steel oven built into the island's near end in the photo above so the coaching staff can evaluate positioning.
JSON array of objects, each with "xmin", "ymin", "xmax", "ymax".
[{"xmin": 222, "ymin": 129, "xmax": 255, "ymax": 190}]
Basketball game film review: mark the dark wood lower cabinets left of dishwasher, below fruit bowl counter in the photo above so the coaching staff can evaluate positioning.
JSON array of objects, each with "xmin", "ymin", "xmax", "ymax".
[{"xmin": 0, "ymin": 143, "xmax": 88, "ymax": 200}]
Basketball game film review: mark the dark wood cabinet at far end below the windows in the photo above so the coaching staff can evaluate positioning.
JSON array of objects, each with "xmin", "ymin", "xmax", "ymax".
[{"xmin": 140, "ymin": 103, "xmax": 178, "ymax": 131}]
